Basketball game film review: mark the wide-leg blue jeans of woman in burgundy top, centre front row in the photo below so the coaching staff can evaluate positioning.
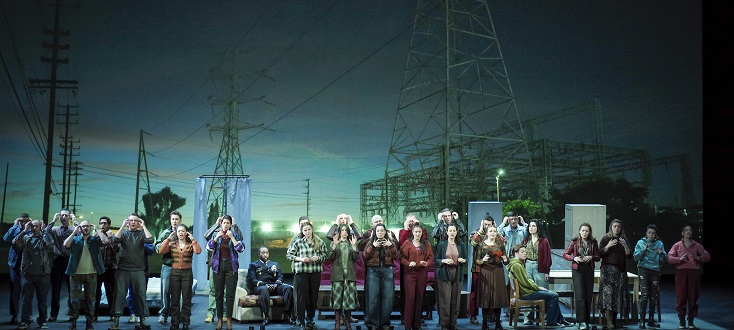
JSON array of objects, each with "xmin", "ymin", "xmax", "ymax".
[{"xmin": 364, "ymin": 267, "xmax": 395, "ymax": 327}]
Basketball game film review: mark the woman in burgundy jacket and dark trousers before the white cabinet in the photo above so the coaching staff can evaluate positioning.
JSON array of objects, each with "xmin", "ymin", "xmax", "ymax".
[{"xmin": 563, "ymin": 222, "xmax": 600, "ymax": 330}]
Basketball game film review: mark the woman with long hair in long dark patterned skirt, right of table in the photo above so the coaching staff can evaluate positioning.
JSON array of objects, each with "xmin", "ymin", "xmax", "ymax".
[{"xmin": 598, "ymin": 219, "xmax": 632, "ymax": 329}]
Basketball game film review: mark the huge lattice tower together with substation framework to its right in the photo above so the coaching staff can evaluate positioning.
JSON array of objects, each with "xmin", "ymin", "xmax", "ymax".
[{"xmin": 360, "ymin": 0, "xmax": 695, "ymax": 224}]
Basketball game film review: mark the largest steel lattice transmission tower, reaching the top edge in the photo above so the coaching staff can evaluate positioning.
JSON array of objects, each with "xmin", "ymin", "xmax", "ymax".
[{"xmin": 361, "ymin": 0, "xmax": 537, "ymax": 223}]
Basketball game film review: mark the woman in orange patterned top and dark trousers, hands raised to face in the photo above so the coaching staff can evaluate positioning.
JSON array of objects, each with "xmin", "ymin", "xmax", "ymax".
[{"xmin": 158, "ymin": 224, "xmax": 201, "ymax": 330}]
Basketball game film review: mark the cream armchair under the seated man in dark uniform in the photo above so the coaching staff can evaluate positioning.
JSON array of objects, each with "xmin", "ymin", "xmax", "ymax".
[{"xmin": 237, "ymin": 269, "xmax": 287, "ymax": 323}]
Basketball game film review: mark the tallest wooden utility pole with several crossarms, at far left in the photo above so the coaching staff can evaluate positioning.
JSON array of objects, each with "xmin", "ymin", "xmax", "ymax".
[{"xmin": 30, "ymin": 0, "xmax": 78, "ymax": 219}]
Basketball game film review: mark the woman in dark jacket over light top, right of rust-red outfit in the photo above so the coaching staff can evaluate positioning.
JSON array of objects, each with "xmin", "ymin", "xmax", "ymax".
[{"xmin": 434, "ymin": 224, "xmax": 467, "ymax": 330}]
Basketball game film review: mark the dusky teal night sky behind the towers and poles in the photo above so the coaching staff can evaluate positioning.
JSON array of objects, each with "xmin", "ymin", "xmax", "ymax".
[{"xmin": 0, "ymin": 0, "xmax": 703, "ymax": 229}]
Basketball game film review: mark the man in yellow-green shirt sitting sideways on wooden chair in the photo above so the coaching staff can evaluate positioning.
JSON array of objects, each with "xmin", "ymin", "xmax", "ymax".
[{"xmin": 507, "ymin": 245, "xmax": 571, "ymax": 326}]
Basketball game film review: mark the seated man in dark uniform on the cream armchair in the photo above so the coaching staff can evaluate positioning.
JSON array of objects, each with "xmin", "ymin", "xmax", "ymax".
[{"xmin": 247, "ymin": 246, "xmax": 296, "ymax": 325}]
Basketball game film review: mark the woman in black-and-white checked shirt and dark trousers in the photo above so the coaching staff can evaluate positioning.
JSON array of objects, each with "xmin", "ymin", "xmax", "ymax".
[{"xmin": 286, "ymin": 222, "xmax": 327, "ymax": 330}]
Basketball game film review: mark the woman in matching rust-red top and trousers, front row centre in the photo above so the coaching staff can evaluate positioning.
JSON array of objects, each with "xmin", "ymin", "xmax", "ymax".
[{"xmin": 400, "ymin": 225, "xmax": 433, "ymax": 330}]
